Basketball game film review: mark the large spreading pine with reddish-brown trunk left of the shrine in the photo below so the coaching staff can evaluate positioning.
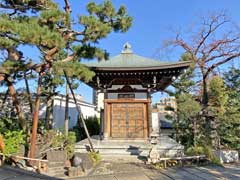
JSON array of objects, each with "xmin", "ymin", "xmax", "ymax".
[{"xmin": 0, "ymin": 0, "xmax": 132, "ymax": 157}]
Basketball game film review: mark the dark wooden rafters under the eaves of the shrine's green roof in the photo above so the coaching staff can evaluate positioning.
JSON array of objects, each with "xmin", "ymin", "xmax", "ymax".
[{"xmin": 88, "ymin": 67, "xmax": 186, "ymax": 92}]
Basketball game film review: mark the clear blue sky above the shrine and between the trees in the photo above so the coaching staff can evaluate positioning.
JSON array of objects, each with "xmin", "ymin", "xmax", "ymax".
[{"xmin": 0, "ymin": 0, "xmax": 240, "ymax": 102}]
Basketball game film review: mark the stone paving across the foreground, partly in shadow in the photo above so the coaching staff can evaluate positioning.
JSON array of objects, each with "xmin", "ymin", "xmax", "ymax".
[{"xmin": 0, "ymin": 162, "xmax": 240, "ymax": 180}]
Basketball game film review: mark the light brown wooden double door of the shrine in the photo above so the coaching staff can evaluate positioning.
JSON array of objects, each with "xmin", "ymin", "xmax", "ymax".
[{"xmin": 111, "ymin": 102, "xmax": 147, "ymax": 139}]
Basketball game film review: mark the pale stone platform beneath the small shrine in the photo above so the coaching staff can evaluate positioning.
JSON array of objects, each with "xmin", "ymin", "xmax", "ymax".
[{"xmin": 75, "ymin": 136, "xmax": 184, "ymax": 161}]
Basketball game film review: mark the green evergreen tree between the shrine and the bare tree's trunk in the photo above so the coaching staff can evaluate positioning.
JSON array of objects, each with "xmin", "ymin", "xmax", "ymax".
[{"xmin": 167, "ymin": 53, "xmax": 200, "ymax": 147}]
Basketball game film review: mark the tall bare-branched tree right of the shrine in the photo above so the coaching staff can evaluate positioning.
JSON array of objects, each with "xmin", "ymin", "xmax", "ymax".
[{"xmin": 167, "ymin": 12, "xmax": 240, "ymax": 107}]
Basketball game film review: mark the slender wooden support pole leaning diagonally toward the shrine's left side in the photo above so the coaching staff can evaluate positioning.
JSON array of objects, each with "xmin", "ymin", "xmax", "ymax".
[{"xmin": 63, "ymin": 70, "xmax": 95, "ymax": 152}]
